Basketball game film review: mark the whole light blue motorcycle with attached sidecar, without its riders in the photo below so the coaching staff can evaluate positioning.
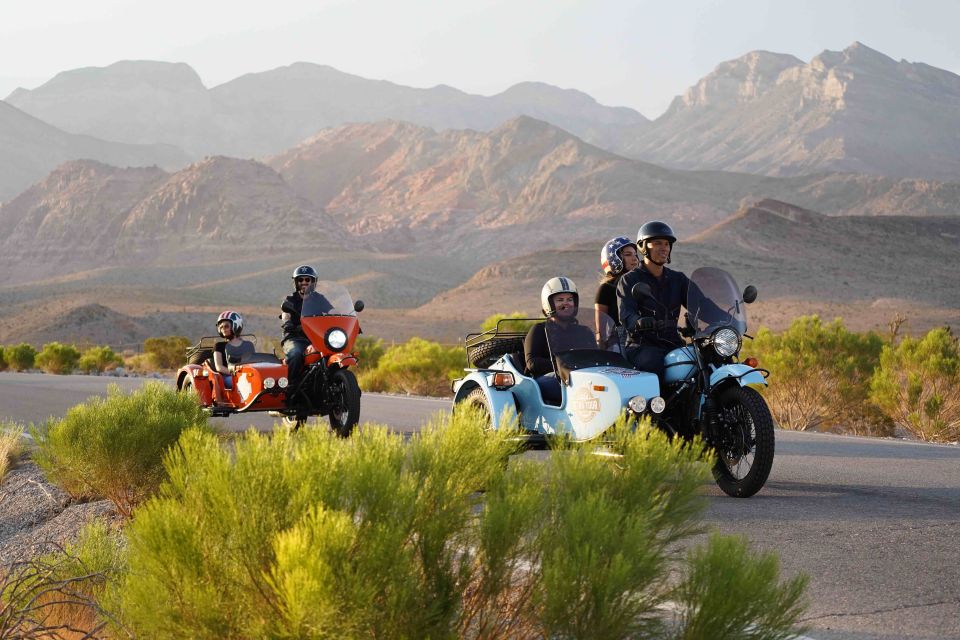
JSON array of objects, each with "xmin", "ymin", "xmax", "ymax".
[{"xmin": 453, "ymin": 267, "xmax": 775, "ymax": 498}]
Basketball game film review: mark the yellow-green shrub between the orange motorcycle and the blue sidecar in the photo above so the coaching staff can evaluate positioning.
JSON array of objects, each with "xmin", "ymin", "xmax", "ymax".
[{"xmin": 360, "ymin": 338, "xmax": 466, "ymax": 396}]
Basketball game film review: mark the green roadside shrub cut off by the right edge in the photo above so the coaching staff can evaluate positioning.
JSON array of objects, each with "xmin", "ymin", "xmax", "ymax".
[{"xmin": 870, "ymin": 328, "xmax": 960, "ymax": 442}]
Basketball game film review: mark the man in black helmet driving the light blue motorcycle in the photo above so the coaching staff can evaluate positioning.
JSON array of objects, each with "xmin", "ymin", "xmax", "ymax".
[{"xmin": 617, "ymin": 220, "xmax": 690, "ymax": 378}]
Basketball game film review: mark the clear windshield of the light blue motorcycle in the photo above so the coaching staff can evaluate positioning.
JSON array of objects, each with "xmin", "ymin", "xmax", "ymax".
[{"xmin": 687, "ymin": 267, "xmax": 747, "ymax": 335}]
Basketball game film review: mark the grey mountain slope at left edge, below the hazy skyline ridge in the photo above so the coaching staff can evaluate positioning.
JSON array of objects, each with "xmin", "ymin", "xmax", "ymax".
[{"xmin": 0, "ymin": 101, "xmax": 188, "ymax": 202}]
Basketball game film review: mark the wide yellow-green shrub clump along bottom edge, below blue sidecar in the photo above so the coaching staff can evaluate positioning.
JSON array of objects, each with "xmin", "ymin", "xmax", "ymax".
[{"xmin": 108, "ymin": 411, "xmax": 804, "ymax": 638}]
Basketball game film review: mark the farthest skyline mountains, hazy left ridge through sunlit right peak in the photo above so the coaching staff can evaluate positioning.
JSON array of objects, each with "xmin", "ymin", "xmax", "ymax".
[{"xmin": 7, "ymin": 42, "xmax": 960, "ymax": 181}]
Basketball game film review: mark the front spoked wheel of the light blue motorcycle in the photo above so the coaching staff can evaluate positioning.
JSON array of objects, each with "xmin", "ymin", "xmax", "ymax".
[{"xmin": 713, "ymin": 387, "xmax": 774, "ymax": 498}]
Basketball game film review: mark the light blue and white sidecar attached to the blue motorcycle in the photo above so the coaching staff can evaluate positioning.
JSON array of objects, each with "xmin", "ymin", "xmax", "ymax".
[{"xmin": 453, "ymin": 309, "xmax": 664, "ymax": 447}]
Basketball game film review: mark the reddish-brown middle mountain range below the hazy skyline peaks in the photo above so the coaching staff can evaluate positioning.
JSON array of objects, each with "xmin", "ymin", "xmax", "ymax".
[{"xmin": 0, "ymin": 117, "xmax": 960, "ymax": 284}]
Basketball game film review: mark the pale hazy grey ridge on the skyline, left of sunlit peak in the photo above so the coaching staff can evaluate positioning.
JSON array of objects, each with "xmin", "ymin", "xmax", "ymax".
[{"xmin": 6, "ymin": 61, "xmax": 647, "ymax": 158}]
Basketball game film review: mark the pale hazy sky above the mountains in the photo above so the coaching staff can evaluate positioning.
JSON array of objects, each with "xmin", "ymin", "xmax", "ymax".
[{"xmin": 0, "ymin": 0, "xmax": 960, "ymax": 118}]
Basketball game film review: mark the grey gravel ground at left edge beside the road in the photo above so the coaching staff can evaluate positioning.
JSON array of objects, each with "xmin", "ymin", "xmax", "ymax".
[{"xmin": 0, "ymin": 460, "xmax": 120, "ymax": 568}]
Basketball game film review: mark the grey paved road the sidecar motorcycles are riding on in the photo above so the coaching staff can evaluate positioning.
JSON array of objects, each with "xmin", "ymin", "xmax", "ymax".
[{"xmin": 0, "ymin": 373, "xmax": 960, "ymax": 640}]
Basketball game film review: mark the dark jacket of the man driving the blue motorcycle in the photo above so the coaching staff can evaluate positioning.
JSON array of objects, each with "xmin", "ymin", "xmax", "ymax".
[{"xmin": 617, "ymin": 263, "xmax": 690, "ymax": 347}]
